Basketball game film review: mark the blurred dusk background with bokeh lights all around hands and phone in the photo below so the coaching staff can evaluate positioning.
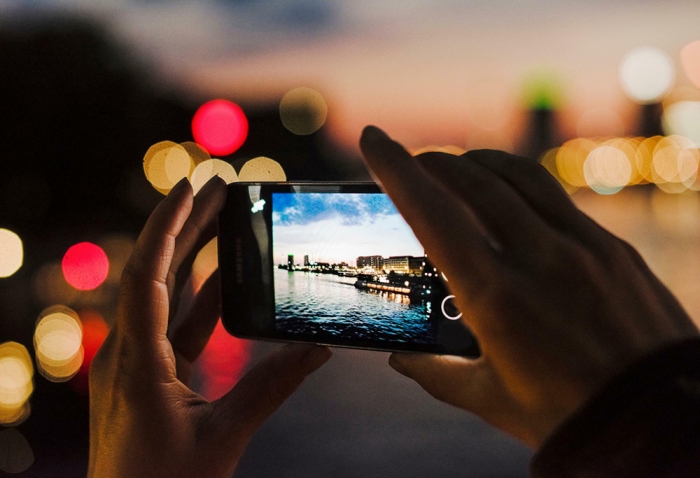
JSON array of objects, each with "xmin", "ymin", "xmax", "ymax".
[{"xmin": 0, "ymin": 0, "xmax": 700, "ymax": 477}]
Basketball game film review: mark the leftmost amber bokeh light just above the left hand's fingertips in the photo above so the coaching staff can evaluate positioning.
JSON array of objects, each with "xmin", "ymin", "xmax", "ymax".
[{"xmin": 143, "ymin": 141, "xmax": 194, "ymax": 194}]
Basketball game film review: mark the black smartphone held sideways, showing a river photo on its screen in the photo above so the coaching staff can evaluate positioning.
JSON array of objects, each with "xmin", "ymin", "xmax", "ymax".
[{"xmin": 218, "ymin": 182, "xmax": 479, "ymax": 357}]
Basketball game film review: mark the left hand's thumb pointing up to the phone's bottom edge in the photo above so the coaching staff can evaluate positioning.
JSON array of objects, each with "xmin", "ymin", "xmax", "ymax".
[{"xmin": 205, "ymin": 344, "xmax": 333, "ymax": 446}]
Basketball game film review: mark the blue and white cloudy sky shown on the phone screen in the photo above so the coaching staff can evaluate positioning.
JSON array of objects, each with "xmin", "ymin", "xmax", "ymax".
[{"xmin": 272, "ymin": 193, "xmax": 423, "ymax": 266}]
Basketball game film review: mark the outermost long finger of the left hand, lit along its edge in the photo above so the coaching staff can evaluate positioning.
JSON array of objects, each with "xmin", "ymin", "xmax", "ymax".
[{"xmin": 117, "ymin": 179, "xmax": 193, "ymax": 342}]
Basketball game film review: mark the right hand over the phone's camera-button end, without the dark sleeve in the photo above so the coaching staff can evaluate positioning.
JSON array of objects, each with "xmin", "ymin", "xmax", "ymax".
[{"xmin": 360, "ymin": 127, "xmax": 698, "ymax": 447}]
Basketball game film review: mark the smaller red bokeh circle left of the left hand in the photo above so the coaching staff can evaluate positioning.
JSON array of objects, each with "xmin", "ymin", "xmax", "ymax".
[{"xmin": 61, "ymin": 242, "xmax": 109, "ymax": 290}]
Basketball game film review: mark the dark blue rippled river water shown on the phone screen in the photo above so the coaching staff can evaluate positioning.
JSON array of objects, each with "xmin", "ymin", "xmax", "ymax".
[{"xmin": 274, "ymin": 269, "xmax": 435, "ymax": 343}]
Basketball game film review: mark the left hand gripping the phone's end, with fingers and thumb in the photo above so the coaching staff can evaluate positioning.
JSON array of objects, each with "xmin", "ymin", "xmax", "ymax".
[{"xmin": 88, "ymin": 178, "xmax": 331, "ymax": 478}]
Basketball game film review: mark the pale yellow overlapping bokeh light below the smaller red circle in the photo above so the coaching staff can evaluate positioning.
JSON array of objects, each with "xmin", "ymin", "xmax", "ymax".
[{"xmin": 34, "ymin": 305, "xmax": 84, "ymax": 382}]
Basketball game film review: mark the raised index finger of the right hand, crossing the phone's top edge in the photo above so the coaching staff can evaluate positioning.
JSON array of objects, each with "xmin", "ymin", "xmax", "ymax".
[{"xmin": 360, "ymin": 126, "xmax": 499, "ymax": 298}]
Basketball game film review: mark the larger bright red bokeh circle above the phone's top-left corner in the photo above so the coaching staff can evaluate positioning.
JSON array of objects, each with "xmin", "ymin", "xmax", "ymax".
[{"xmin": 192, "ymin": 100, "xmax": 248, "ymax": 156}]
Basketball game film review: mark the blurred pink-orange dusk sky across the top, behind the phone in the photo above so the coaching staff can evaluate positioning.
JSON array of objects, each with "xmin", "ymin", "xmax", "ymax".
[{"xmin": 5, "ymin": 0, "xmax": 700, "ymax": 150}]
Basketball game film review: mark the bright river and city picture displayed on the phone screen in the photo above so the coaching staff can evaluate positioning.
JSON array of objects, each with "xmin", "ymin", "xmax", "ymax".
[{"xmin": 272, "ymin": 193, "xmax": 457, "ymax": 344}]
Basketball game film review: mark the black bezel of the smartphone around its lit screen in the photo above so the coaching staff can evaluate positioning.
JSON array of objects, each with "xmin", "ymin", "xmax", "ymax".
[{"xmin": 218, "ymin": 182, "xmax": 479, "ymax": 357}]
